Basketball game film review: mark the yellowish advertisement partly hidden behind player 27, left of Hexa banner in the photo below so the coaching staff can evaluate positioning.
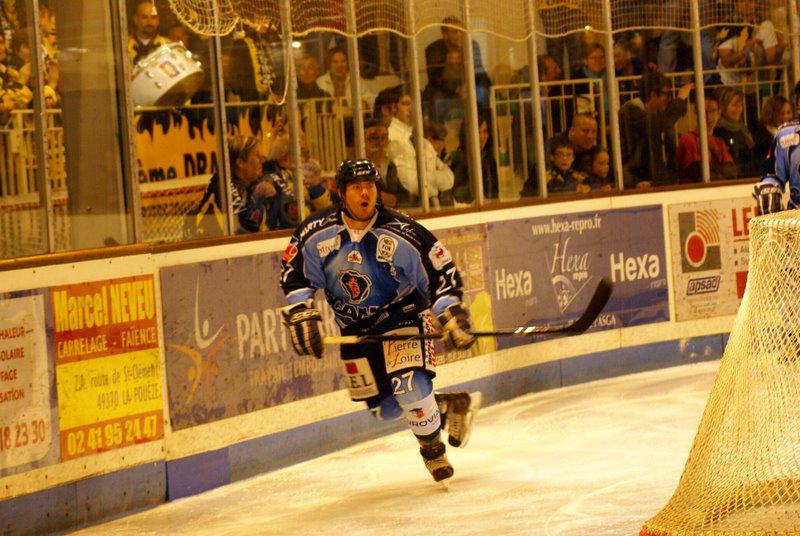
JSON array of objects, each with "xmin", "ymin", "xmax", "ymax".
[{"xmin": 435, "ymin": 224, "xmax": 496, "ymax": 365}]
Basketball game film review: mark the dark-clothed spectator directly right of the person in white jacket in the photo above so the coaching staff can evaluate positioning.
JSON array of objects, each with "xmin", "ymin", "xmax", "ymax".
[{"xmin": 448, "ymin": 115, "xmax": 499, "ymax": 203}]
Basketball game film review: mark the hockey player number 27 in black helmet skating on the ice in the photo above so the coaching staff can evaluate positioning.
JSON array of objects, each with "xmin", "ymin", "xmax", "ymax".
[{"xmin": 281, "ymin": 160, "xmax": 481, "ymax": 482}]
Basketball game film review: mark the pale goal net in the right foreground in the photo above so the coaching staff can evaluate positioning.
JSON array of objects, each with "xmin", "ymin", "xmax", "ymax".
[{"xmin": 640, "ymin": 211, "xmax": 800, "ymax": 536}]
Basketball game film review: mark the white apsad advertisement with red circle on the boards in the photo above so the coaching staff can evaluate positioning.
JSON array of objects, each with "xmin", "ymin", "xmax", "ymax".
[{"xmin": 669, "ymin": 198, "xmax": 757, "ymax": 322}]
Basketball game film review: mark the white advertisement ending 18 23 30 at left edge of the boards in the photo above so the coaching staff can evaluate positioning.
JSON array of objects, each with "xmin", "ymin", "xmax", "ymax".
[{"xmin": 0, "ymin": 294, "xmax": 53, "ymax": 470}]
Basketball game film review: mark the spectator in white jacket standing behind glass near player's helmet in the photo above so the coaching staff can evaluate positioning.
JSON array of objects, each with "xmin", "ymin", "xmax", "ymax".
[{"xmin": 389, "ymin": 88, "xmax": 453, "ymax": 208}]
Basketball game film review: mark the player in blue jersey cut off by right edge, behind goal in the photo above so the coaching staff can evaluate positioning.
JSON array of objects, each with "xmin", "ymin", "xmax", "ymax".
[{"xmin": 753, "ymin": 82, "xmax": 800, "ymax": 214}]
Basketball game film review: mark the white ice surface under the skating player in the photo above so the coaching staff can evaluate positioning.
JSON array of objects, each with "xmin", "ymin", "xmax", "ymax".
[{"xmin": 75, "ymin": 362, "xmax": 718, "ymax": 536}]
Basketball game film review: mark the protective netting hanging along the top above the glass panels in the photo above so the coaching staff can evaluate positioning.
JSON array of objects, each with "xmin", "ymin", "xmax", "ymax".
[{"xmin": 169, "ymin": 0, "xmax": 790, "ymax": 40}]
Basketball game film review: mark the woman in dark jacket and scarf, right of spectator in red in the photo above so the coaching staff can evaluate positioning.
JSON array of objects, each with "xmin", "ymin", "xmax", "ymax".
[{"xmin": 714, "ymin": 86, "xmax": 757, "ymax": 177}]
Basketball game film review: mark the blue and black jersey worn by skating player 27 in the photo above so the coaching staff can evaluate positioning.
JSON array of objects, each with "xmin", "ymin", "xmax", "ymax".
[{"xmin": 281, "ymin": 205, "xmax": 462, "ymax": 331}]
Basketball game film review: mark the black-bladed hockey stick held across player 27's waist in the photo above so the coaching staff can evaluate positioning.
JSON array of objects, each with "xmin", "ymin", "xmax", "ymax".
[{"xmin": 324, "ymin": 278, "xmax": 614, "ymax": 344}]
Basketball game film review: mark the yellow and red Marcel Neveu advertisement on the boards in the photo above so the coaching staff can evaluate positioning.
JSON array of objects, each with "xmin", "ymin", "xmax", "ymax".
[{"xmin": 51, "ymin": 275, "xmax": 164, "ymax": 460}]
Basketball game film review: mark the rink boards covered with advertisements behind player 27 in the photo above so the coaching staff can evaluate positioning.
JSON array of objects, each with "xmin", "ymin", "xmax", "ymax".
[{"xmin": 0, "ymin": 184, "xmax": 755, "ymax": 532}]
